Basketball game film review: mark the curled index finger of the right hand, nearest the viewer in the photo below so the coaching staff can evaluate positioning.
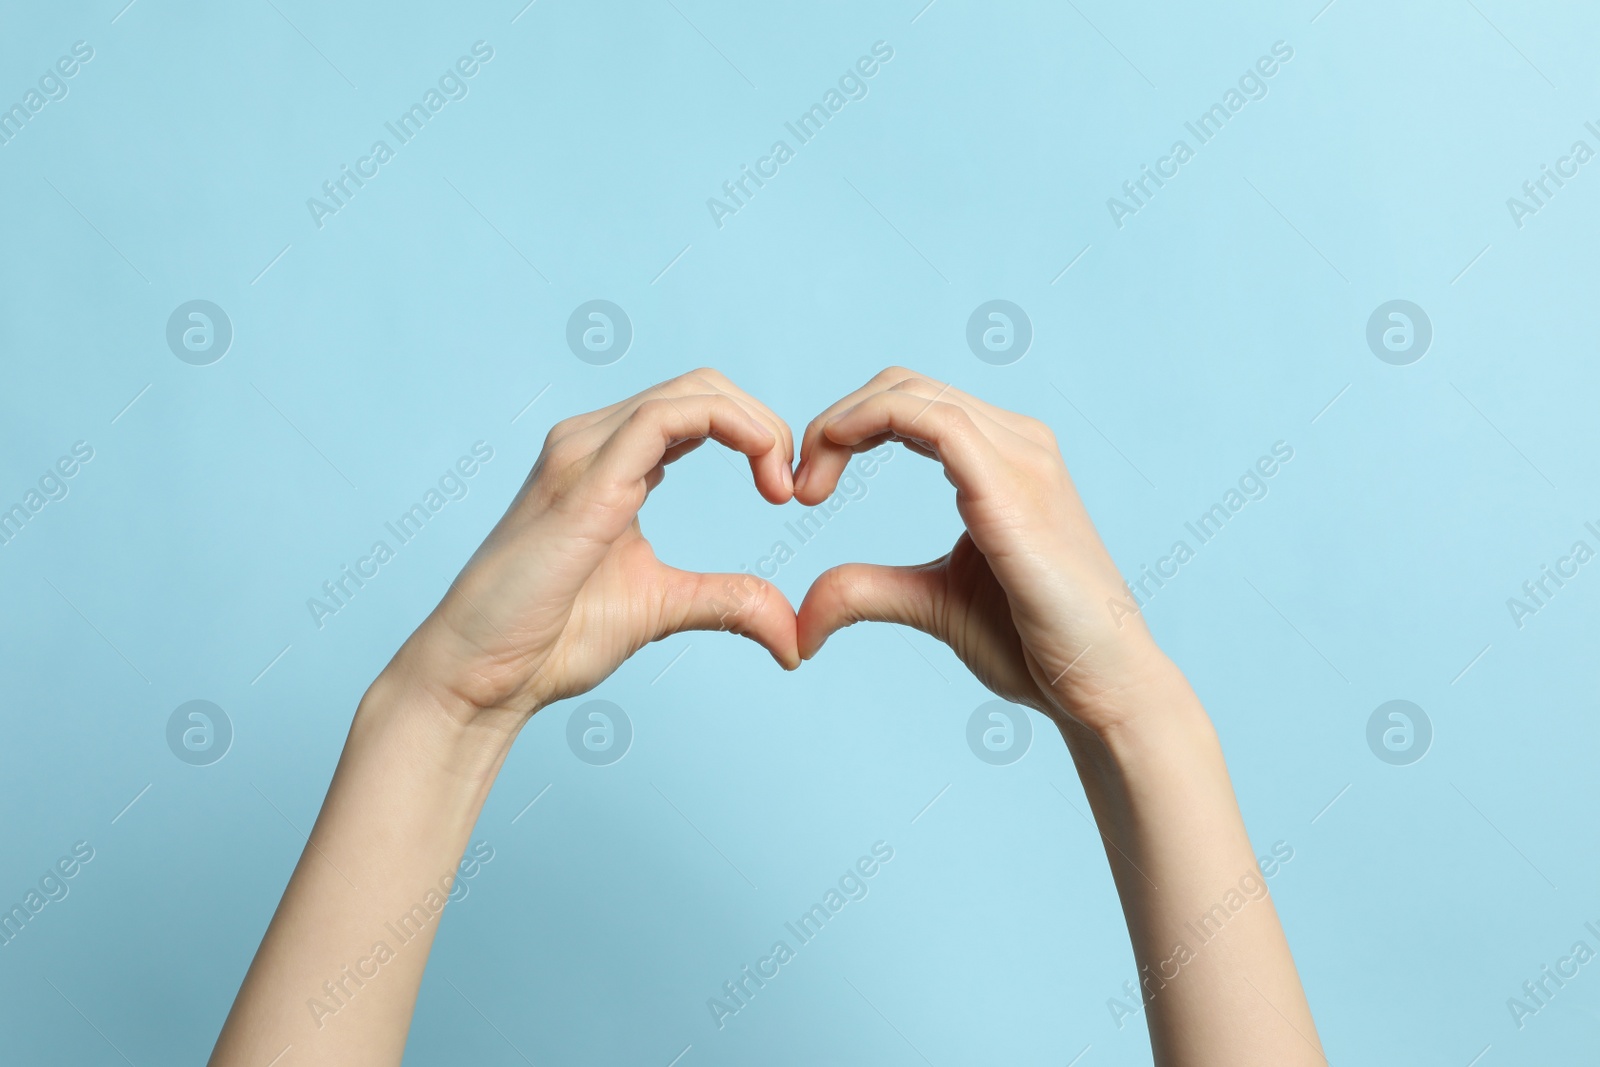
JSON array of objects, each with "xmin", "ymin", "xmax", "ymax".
[{"xmin": 795, "ymin": 390, "xmax": 1000, "ymax": 504}]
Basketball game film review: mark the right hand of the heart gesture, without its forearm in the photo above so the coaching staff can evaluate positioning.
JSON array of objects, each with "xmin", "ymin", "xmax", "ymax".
[{"xmin": 795, "ymin": 366, "xmax": 1170, "ymax": 734}]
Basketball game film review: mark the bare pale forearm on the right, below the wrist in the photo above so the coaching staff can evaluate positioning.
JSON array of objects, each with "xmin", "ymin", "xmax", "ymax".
[{"xmin": 1067, "ymin": 659, "xmax": 1325, "ymax": 1067}]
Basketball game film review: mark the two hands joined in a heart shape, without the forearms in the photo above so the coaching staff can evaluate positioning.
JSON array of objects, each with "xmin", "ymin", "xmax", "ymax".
[{"xmin": 425, "ymin": 366, "xmax": 1147, "ymax": 729}]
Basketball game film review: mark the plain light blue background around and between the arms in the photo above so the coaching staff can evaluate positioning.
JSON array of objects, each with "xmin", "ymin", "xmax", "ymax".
[{"xmin": 0, "ymin": 0, "xmax": 1600, "ymax": 1067}]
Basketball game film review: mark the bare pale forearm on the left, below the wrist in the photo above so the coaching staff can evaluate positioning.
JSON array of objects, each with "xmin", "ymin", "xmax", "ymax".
[{"xmin": 211, "ymin": 669, "xmax": 514, "ymax": 1067}]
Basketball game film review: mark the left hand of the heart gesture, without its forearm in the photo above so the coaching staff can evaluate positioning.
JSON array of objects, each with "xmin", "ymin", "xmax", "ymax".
[{"xmin": 390, "ymin": 370, "xmax": 800, "ymax": 726}]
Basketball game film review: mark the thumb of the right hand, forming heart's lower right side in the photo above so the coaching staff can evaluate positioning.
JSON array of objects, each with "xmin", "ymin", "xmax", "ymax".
[{"xmin": 795, "ymin": 560, "xmax": 944, "ymax": 659}]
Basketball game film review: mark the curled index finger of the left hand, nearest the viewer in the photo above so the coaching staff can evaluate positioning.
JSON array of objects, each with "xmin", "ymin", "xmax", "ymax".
[{"xmin": 589, "ymin": 394, "xmax": 789, "ymax": 504}]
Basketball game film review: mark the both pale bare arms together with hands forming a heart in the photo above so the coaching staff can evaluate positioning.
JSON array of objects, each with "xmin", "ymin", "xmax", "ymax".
[{"xmin": 211, "ymin": 368, "xmax": 1326, "ymax": 1067}]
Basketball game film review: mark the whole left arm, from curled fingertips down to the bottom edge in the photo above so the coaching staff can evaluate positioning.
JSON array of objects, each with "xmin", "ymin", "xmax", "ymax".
[{"xmin": 211, "ymin": 370, "xmax": 798, "ymax": 1067}]
